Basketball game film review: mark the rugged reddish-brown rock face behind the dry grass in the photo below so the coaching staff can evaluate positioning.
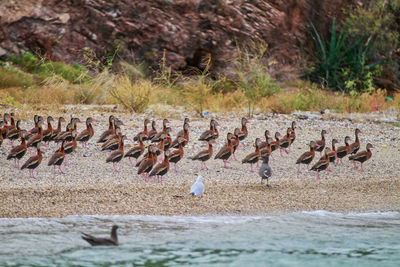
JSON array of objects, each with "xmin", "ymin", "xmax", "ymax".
[{"xmin": 0, "ymin": 0, "xmax": 359, "ymax": 76}]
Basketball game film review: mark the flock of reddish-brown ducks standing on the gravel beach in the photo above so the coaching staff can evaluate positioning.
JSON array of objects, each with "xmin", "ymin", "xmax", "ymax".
[{"xmin": 0, "ymin": 113, "xmax": 373, "ymax": 186}]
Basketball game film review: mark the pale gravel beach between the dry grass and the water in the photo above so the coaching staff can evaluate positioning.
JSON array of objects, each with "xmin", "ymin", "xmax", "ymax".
[{"xmin": 0, "ymin": 105, "xmax": 400, "ymax": 217}]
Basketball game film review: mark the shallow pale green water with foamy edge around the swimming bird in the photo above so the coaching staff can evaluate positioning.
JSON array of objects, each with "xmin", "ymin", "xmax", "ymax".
[{"xmin": 0, "ymin": 211, "xmax": 400, "ymax": 266}]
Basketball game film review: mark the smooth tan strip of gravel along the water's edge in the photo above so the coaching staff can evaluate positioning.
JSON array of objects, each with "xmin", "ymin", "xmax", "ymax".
[{"xmin": 0, "ymin": 177, "xmax": 400, "ymax": 218}]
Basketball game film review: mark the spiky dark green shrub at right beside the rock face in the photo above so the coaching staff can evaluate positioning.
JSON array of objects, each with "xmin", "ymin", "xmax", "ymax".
[{"xmin": 301, "ymin": 19, "xmax": 383, "ymax": 92}]
